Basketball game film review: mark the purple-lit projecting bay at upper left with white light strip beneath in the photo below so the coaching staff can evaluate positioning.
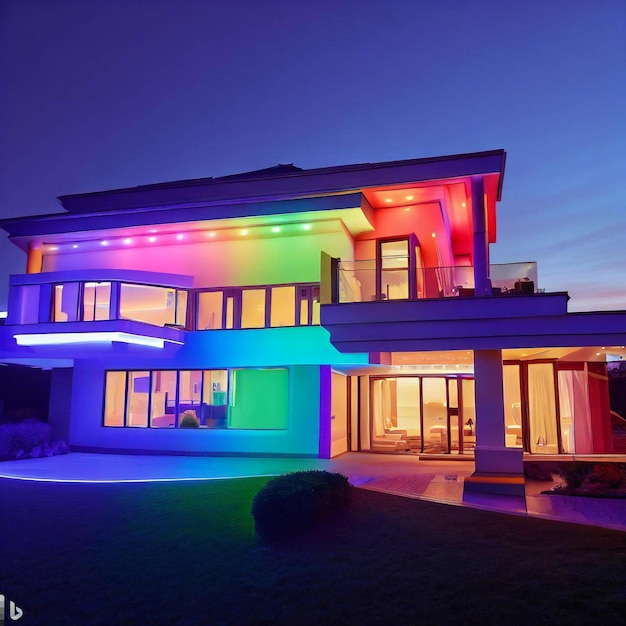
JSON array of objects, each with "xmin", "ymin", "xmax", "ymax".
[{"xmin": 3, "ymin": 270, "xmax": 191, "ymax": 356}]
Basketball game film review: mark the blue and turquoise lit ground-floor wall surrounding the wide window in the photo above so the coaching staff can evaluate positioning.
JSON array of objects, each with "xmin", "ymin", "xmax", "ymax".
[{"xmin": 64, "ymin": 327, "xmax": 367, "ymax": 456}]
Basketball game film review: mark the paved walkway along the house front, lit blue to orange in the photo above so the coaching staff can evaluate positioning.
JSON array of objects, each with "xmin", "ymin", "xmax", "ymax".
[{"xmin": 0, "ymin": 452, "xmax": 626, "ymax": 531}]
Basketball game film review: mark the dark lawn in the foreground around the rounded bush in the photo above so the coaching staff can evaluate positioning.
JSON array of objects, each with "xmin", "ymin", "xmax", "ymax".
[{"xmin": 0, "ymin": 479, "xmax": 626, "ymax": 626}]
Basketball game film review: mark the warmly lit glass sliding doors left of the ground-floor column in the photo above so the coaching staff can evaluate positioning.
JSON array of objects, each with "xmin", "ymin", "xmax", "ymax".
[{"xmin": 370, "ymin": 376, "xmax": 476, "ymax": 454}]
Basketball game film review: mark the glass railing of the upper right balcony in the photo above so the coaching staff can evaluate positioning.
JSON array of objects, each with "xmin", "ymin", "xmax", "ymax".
[{"xmin": 334, "ymin": 259, "xmax": 540, "ymax": 303}]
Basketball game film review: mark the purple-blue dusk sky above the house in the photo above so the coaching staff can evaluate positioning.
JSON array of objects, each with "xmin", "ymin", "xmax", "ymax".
[{"xmin": 0, "ymin": 0, "xmax": 626, "ymax": 311}]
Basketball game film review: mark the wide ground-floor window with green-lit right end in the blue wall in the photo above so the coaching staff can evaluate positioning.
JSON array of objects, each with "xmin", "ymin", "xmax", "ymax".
[{"xmin": 104, "ymin": 368, "xmax": 288, "ymax": 430}]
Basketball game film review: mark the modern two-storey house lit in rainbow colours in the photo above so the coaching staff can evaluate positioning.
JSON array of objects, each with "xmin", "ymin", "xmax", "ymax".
[{"xmin": 0, "ymin": 150, "xmax": 626, "ymax": 490}]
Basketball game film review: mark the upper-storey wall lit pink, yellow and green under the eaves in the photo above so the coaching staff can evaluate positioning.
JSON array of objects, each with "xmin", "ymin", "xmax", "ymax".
[{"xmin": 44, "ymin": 230, "xmax": 353, "ymax": 287}]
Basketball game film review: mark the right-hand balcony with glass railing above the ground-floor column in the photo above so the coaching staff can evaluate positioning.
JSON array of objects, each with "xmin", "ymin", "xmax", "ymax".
[{"xmin": 321, "ymin": 257, "xmax": 582, "ymax": 353}]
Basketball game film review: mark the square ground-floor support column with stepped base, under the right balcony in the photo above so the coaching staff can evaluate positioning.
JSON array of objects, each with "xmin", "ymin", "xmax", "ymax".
[{"xmin": 465, "ymin": 350, "xmax": 524, "ymax": 496}]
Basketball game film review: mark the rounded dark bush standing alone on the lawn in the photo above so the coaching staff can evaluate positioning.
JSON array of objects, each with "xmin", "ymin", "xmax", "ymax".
[{"xmin": 252, "ymin": 470, "xmax": 352, "ymax": 541}]
